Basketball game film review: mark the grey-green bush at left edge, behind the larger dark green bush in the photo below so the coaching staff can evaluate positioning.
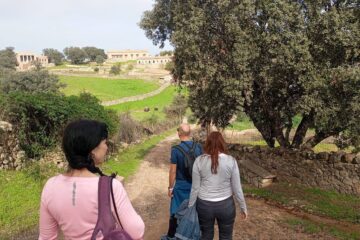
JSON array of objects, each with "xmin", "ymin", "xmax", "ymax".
[{"xmin": 0, "ymin": 69, "xmax": 65, "ymax": 93}]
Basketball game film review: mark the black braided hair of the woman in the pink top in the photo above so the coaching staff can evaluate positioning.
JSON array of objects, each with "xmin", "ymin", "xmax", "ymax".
[{"xmin": 62, "ymin": 120, "xmax": 108, "ymax": 176}]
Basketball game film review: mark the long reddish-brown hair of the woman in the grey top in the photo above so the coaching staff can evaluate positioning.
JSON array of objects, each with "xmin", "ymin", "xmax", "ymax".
[{"xmin": 204, "ymin": 132, "xmax": 227, "ymax": 174}]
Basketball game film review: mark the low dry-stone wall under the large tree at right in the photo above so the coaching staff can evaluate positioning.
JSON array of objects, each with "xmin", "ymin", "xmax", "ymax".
[{"xmin": 229, "ymin": 144, "xmax": 360, "ymax": 196}]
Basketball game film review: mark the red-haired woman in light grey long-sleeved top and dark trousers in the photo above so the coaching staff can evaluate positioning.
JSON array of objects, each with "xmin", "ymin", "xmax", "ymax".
[{"xmin": 189, "ymin": 132, "xmax": 247, "ymax": 240}]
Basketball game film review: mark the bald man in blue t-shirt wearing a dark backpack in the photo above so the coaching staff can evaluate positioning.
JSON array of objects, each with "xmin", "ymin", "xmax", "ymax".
[{"xmin": 161, "ymin": 123, "xmax": 202, "ymax": 240}]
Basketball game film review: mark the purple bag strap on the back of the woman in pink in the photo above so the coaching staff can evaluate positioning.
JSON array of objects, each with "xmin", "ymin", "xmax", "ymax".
[{"xmin": 91, "ymin": 176, "xmax": 117, "ymax": 240}]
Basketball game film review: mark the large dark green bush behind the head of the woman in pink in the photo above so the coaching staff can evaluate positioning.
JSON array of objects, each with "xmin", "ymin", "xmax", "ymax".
[{"xmin": 3, "ymin": 92, "xmax": 117, "ymax": 158}]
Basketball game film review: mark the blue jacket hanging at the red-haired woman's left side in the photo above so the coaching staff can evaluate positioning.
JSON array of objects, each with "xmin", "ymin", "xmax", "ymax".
[{"xmin": 175, "ymin": 199, "xmax": 200, "ymax": 240}]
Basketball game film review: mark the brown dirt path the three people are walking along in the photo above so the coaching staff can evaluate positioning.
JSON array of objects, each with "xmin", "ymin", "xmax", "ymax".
[{"xmin": 125, "ymin": 136, "xmax": 334, "ymax": 240}]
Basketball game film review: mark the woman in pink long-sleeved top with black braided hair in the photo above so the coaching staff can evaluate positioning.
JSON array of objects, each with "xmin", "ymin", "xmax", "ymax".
[{"xmin": 39, "ymin": 120, "xmax": 145, "ymax": 240}]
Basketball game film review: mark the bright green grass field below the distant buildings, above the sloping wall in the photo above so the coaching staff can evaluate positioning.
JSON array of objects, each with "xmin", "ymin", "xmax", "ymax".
[{"xmin": 59, "ymin": 76, "xmax": 159, "ymax": 101}]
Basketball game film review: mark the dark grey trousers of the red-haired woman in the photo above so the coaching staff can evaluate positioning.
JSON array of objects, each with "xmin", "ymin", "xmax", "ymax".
[{"xmin": 196, "ymin": 197, "xmax": 236, "ymax": 240}]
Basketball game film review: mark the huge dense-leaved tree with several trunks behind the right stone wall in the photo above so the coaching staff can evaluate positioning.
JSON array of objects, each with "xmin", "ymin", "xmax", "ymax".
[{"xmin": 140, "ymin": 0, "xmax": 360, "ymax": 148}]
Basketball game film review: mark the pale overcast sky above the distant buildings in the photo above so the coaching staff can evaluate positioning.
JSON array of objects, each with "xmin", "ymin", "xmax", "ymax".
[{"xmin": 0, "ymin": 0, "xmax": 171, "ymax": 54}]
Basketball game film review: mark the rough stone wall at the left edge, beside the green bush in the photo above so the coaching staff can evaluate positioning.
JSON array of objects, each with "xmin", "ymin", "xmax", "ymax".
[{"xmin": 0, "ymin": 121, "xmax": 25, "ymax": 170}]
